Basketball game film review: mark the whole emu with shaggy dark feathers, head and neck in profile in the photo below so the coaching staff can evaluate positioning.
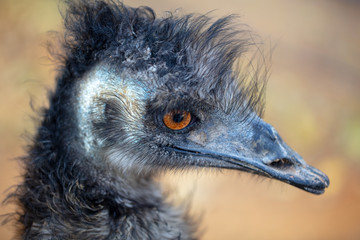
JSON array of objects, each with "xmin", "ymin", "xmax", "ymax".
[{"xmin": 11, "ymin": 0, "xmax": 329, "ymax": 239}]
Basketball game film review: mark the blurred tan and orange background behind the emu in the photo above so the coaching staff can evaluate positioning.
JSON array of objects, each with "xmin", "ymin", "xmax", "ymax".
[{"xmin": 0, "ymin": 0, "xmax": 360, "ymax": 240}]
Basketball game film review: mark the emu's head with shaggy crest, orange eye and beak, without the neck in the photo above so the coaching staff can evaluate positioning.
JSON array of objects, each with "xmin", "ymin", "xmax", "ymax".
[{"xmin": 66, "ymin": 0, "xmax": 329, "ymax": 194}]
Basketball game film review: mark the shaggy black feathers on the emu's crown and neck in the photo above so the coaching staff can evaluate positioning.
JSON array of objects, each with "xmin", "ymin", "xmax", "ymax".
[{"xmin": 4, "ymin": 0, "xmax": 266, "ymax": 239}]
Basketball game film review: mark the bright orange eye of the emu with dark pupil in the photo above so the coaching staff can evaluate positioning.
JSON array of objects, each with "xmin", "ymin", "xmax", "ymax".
[{"xmin": 163, "ymin": 110, "xmax": 191, "ymax": 130}]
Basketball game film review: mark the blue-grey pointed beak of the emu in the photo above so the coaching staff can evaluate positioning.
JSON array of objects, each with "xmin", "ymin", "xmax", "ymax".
[{"xmin": 172, "ymin": 118, "xmax": 329, "ymax": 194}]
